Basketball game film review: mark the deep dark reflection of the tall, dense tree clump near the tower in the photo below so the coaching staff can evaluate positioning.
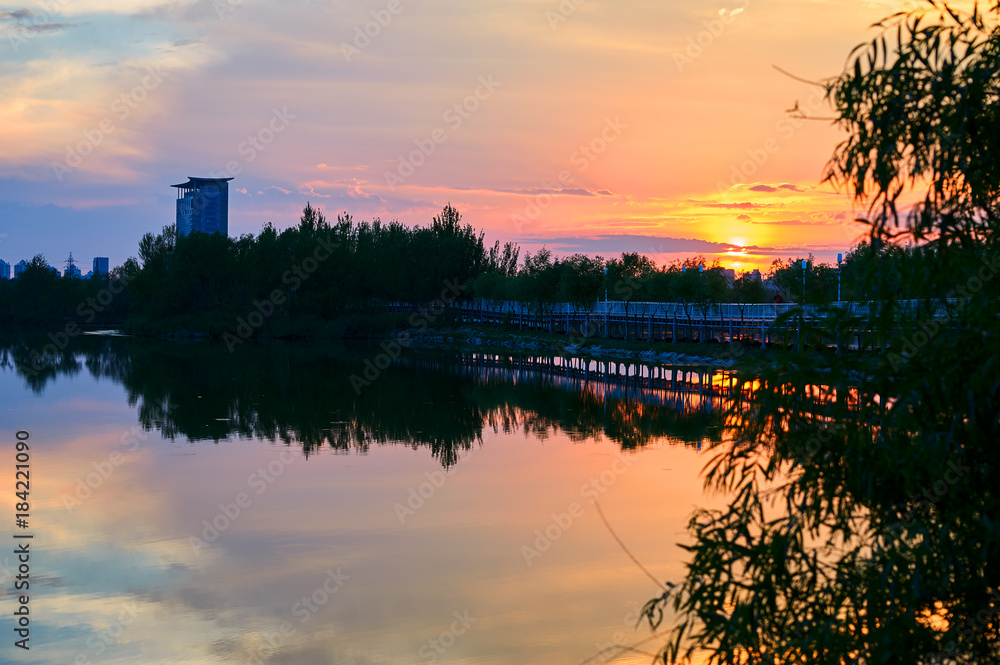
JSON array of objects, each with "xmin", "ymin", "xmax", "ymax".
[{"xmin": 113, "ymin": 343, "xmax": 483, "ymax": 466}]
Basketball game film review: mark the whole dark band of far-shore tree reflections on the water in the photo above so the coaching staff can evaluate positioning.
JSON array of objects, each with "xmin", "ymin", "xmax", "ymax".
[{"xmin": 0, "ymin": 337, "xmax": 721, "ymax": 467}]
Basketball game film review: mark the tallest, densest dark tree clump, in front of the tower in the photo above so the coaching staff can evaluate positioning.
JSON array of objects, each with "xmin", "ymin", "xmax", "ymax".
[{"xmin": 120, "ymin": 204, "xmax": 518, "ymax": 336}]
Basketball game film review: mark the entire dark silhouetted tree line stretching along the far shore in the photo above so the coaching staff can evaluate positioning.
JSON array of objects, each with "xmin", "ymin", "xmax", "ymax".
[{"xmin": 0, "ymin": 198, "xmax": 948, "ymax": 337}]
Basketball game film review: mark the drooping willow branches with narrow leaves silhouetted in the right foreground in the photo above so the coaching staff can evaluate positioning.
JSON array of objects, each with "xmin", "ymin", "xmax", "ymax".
[{"xmin": 644, "ymin": 0, "xmax": 1000, "ymax": 665}]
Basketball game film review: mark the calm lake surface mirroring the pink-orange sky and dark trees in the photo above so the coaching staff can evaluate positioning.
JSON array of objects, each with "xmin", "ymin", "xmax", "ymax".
[{"xmin": 0, "ymin": 338, "xmax": 720, "ymax": 665}]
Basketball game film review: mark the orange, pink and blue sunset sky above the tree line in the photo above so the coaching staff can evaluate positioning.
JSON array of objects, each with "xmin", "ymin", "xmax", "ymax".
[{"xmin": 0, "ymin": 0, "xmax": 915, "ymax": 271}]
